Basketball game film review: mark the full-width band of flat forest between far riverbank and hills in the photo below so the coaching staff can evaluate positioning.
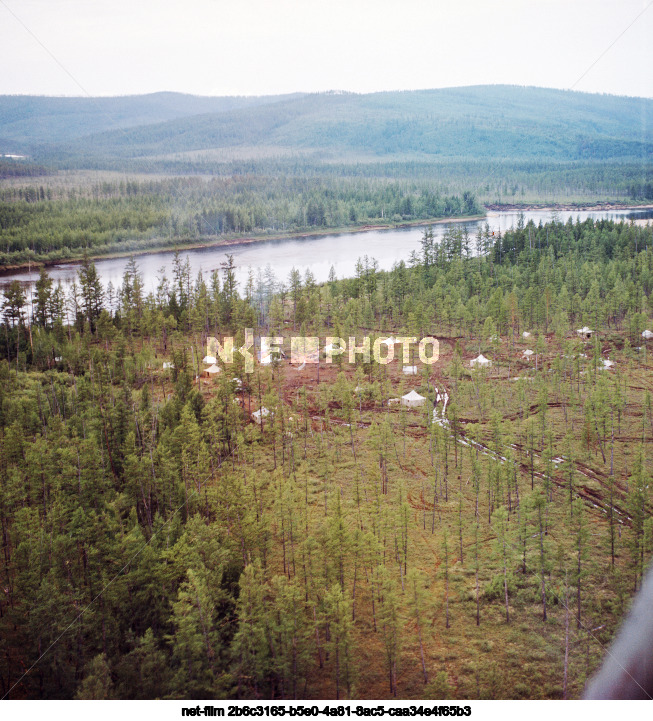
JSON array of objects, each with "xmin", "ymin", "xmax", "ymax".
[{"xmin": 0, "ymin": 160, "xmax": 653, "ymax": 267}]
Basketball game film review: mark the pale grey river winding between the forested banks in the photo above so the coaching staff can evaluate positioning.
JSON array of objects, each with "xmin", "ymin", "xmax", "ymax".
[{"xmin": 0, "ymin": 209, "xmax": 651, "ymax": 297}]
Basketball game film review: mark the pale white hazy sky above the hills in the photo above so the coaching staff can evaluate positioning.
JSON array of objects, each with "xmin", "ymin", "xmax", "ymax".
[{"xmin": 0, "ymin": 0, "xmax": 653, "ymax": 97}]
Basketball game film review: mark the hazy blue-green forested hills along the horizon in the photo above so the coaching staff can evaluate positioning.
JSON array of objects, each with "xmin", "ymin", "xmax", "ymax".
[{"xmin": 0, "ymin": 85, "xmax": 653, "ymax": 166}]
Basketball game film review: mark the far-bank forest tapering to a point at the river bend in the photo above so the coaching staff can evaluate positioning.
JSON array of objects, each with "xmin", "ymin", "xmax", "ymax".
[{"xmin": 0, "ymin": 175, "xmax": 483, "ymax": 266}]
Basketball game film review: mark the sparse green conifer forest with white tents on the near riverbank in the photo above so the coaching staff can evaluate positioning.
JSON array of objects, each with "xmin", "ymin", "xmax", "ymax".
[{"xmin": 0, "ymin": 215, "xmax": 653, "ymax": 699}]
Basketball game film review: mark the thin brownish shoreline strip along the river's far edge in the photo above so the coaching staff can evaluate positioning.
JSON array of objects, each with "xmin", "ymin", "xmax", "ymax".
[{"xmin": 0, "ymin": 201, "xmax": 653, "ymax": 277}]
